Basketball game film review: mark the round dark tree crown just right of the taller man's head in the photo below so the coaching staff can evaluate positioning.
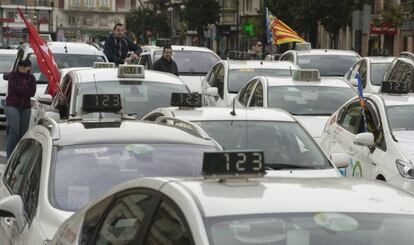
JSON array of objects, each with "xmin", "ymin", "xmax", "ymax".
[{"xmin": 125, "ymin": 9, "xmax": 170, "ymax": 43}]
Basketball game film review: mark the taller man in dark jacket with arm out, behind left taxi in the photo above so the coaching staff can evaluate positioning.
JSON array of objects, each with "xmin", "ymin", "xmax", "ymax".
[{"xmin": 104, "ymin": 23, "xmax": 142, "ymax": 66}]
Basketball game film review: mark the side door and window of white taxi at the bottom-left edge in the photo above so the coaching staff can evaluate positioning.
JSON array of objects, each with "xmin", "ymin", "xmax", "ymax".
[{"xmin": 0, "ymin": 139, "xmax": 42, "ymax": 244}]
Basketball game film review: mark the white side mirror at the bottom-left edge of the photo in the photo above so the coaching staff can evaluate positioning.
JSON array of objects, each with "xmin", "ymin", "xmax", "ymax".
[{"xmin": 0, "ymin": 195, "xmax": 26, "ymax": 232}]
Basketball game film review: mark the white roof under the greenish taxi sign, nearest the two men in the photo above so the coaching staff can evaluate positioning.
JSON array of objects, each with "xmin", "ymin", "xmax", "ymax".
[{"xmin": 70, "ymin": 68, "xmax": 186, "ymax": 86}]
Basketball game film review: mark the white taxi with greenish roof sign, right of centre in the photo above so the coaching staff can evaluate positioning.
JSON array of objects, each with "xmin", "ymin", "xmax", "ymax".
[{"xmin": 235, "ymin": 69, "xmax": 356, "ymax": 141}]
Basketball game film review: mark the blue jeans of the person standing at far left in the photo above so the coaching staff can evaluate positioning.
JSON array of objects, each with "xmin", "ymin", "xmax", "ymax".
[{"xmin": 5, "ymin": 106, "xmax": 32, "ymax": 158}]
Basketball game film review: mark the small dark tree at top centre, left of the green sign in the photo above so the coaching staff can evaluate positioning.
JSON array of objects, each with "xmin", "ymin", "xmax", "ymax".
[{"xmin": 183, "ymin": 0, "xmax": 220, "ymax": 45}]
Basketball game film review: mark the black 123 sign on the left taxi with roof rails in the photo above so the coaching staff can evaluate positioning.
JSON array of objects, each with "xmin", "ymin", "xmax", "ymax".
[{"xmin": 82, "ymin": 94, "xmax": 122, "ymax": 112}]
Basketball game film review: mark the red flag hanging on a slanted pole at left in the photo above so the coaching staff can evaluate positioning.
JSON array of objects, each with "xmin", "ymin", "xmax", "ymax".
[{"xmin": 17, "ymin": 8, "xmax": 60, "ymax": 96}]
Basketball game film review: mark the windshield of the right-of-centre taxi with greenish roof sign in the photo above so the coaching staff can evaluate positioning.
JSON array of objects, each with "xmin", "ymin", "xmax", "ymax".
[{"xmin": 268, "ymin": 86, "xmax": 356, "ymax": 116}]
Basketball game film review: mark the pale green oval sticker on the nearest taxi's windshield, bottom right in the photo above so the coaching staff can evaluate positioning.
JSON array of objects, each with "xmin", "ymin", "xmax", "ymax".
[{"xmin": 313, "ymin": 213, "xmax": 359, "ymax": 231}]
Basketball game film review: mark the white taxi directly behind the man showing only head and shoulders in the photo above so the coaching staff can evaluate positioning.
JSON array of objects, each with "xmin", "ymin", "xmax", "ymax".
[{"xmin": 138, "ymin": 45, "xmax": 221, "ymax": 93}]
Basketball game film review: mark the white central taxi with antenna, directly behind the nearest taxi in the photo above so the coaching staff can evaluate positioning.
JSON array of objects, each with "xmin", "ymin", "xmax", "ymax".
[{"xmin": 142, "ymin": 94, "xmax": 348, "ymax": 177}]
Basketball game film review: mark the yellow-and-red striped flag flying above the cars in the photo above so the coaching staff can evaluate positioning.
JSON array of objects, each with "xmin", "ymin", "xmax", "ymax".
[{"xmin": 266, "ymin": 11, "xmax": 306, "ymax": 45}]
